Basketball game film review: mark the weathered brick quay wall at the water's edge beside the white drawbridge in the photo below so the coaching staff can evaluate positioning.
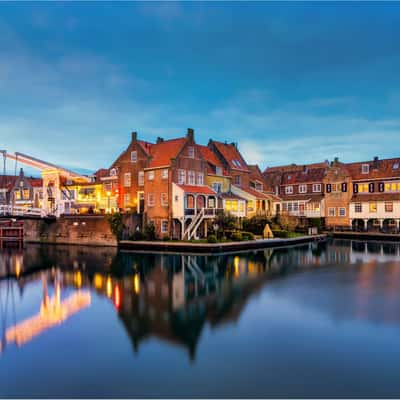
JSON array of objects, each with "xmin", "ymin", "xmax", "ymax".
[{"xmin": 24, "ymin": 216, "xmax": 117, "ymax": 246}]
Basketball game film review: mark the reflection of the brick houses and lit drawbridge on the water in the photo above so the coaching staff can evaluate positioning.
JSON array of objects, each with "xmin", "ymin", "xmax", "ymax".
[{"xmin": 0, "ymin": 241, "xmax": 400, "ymax": 359}]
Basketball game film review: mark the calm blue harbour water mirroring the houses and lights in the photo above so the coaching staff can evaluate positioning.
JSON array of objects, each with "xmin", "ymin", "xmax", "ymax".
[{"xmin": 0, "ymin": 240, "xmax": 400, "ymax": 397}]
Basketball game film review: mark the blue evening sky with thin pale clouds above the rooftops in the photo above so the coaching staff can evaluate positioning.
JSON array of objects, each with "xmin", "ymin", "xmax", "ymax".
[{"xmin": 0, "ymin": 2, "xmax": 400, "ymax": 176}]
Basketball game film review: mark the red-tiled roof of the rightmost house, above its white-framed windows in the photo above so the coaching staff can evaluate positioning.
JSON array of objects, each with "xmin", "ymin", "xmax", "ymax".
[{"xmin": 346, "ymin": 158, "xmax": 400, "ymax": 180}]
